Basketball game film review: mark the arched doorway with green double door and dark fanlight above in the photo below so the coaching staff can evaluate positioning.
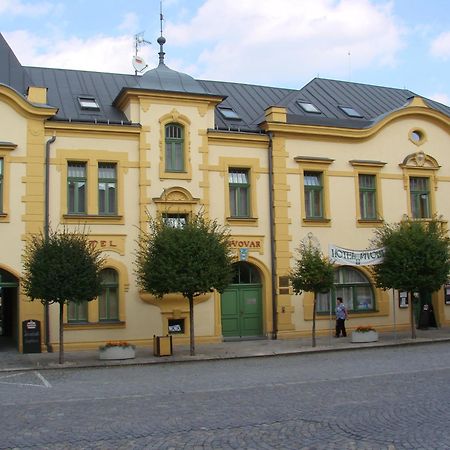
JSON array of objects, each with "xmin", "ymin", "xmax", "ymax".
[{"xmin": 221, "ymin": 262, "xmax": 263, "ymax": 339}]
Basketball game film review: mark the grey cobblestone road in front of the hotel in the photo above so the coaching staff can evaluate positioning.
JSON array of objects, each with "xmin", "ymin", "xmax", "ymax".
[{"xmin": 0, "ymin": 343, "xmax": 450, "ymax": 450}]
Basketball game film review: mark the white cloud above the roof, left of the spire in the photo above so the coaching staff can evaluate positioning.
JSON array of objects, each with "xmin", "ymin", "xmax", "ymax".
[{"xmin": 4, "ymin": 31, "xmax": 155, "ymax": 73}]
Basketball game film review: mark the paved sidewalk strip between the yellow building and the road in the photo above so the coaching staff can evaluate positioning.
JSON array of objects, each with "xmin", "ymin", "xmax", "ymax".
[{"xmin": 0, "ymin": 327, "xmax": 450, "ymax": 372}]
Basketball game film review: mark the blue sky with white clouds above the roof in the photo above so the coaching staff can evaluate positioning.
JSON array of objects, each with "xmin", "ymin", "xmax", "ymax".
[{"xmin": 0, "ymin": 0, "xmax": 450, "ymax": 105}]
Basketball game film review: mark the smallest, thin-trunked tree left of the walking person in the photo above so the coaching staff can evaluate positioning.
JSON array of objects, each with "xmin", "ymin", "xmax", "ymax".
[{"xmin": 289, "ymin": 240, "xmax": 334, "ymax": 347}]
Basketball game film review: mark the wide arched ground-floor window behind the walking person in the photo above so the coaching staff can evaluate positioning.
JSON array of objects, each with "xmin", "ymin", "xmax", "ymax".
[{"xmin": 317, "ymin": 267, "xmax": 375, "ymax": 313}]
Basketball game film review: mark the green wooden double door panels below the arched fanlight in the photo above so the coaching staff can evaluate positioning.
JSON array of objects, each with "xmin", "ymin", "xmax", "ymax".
[{"xmin": 221, "ymin": 284, "xmax": 262, "ymax": 337}]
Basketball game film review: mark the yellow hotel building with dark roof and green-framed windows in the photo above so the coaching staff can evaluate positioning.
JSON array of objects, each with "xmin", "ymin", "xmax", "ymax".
[{"xmin": 0, "ymin": 33, "xmax": 450, "ymax": 351}]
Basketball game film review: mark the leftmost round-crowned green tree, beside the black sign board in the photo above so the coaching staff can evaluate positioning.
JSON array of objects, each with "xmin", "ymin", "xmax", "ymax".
[{"xmin": 22, "ymin": 228, "xmax": 103, "ymax": 364}]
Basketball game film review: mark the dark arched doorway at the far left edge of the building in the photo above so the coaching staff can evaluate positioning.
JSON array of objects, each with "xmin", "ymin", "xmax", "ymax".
[{"xmin": 0, "ymin": 269, "xmax": 19, "ymax": 346}]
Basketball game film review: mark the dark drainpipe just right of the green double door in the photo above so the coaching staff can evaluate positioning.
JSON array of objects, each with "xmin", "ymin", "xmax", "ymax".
[{"xmin": 268, "ymin": 131, "xmax": 278, "ymax": 340}]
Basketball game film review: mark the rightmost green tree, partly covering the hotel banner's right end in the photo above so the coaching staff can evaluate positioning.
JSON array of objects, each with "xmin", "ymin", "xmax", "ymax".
[{"xmin": 372, "ymin": 219, "xmax": 450, "ymax": 339}]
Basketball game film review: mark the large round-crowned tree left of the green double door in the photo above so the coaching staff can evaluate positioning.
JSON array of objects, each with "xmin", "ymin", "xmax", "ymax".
[{"xmin": 135, "ymin": 213, "xmax": 233, "ymax": 355}]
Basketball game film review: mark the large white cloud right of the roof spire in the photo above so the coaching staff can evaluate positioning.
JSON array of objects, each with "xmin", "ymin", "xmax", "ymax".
[{"xmin": 166, "ymin": 0, "xmax": 403, "ymax": 85}]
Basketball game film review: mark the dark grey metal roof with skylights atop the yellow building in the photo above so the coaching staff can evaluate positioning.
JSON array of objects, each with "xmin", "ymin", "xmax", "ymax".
[{"xmin": 0, "ymin": 33, "xmax": 450, "ymax": 132}]
